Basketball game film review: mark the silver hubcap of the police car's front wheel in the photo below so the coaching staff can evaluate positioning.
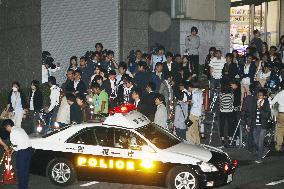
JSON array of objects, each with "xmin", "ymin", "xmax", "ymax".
[{"xmin": 175, "ymin": 172, "xmax": 195, "ymax": 189}]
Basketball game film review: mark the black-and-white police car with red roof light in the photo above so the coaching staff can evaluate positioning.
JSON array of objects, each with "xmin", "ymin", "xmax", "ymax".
[{"xmin": 31, "ymin": 105, "xmax": 237, "ymax": 189}]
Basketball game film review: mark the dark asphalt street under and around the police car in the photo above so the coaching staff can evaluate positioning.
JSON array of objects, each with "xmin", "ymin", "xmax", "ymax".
[{"xmin": 0, "ymin": 149, "xmax": 284, "ymax": 189}]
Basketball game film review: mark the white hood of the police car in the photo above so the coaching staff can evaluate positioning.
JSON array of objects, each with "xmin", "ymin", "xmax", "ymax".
[{"xmin": 165, "ymin": 142, "xmax": 212, "ymax": 162}]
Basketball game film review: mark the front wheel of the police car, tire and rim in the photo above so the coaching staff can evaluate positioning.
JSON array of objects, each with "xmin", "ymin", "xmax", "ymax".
[{"xmin": 166, "ymin": 167, "xmax": 199, "ymax": 189}]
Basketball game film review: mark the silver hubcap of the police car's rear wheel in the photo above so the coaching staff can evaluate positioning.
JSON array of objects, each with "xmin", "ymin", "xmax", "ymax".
[{"xmin": 51, "ymin": 163, "xmax": 71, "ymax": 183}]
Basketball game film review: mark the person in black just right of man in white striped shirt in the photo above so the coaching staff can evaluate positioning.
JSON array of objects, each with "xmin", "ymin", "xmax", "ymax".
[{"xmin": 222, "ymin": 53, "xmax": 239, "ymax": 82}]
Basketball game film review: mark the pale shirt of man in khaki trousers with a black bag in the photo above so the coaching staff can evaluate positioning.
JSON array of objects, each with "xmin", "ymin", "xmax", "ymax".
[{"xmin": 190, "ymin": 89, "xmax": 203, "ymax": 116}]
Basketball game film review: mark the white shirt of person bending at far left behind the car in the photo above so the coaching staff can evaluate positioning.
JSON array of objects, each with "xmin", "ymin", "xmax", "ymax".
[{"xmin": 10, "ymin": 126, "xmax": 31, "ymax": 151}]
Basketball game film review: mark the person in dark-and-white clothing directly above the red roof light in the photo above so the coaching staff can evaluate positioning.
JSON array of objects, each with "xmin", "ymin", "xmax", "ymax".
[{"xmin": 117, "ymin": 75, "xmax": 135, "ymax": 105}]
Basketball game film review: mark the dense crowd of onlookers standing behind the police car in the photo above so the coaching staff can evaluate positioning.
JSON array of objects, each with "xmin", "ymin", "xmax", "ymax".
[{"xmin": 2, "ymin": 27, "xmax": 284, "ymax": 162}]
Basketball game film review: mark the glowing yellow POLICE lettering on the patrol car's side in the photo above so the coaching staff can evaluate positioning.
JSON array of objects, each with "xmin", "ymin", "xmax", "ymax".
[{"xmin": 77, "ymin": 156, "xmax": 135, "ymax": 170}]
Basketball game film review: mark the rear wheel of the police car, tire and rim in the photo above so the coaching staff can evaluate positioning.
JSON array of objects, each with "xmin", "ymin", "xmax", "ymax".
[{"xmin": 47, "ymin": 159, "xmax": 76, "ymax": 186}]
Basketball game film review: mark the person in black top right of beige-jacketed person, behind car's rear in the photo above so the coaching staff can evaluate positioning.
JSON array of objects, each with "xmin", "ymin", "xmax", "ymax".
[{"xmin": 66, "ymin": 94, "xmax": 83, "ymax": 124}]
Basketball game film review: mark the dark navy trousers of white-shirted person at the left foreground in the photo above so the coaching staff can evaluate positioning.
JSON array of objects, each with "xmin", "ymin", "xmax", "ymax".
[{"xmin": 16, "ymin": 148, "xmax": 32, "ymax": 189}]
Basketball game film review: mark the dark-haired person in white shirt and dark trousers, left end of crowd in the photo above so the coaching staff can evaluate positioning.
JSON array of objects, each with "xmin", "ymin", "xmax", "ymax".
[{"xmin": 45, "ymin": 76, "xmax": 61, "ymax": 129}]
